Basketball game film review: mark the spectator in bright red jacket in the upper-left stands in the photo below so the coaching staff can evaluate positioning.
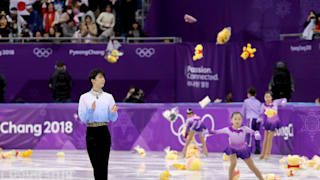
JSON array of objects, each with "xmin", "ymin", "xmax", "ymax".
[{"xmin": 43, "ymin": 3, "xmax": 59, "ymax": 32}]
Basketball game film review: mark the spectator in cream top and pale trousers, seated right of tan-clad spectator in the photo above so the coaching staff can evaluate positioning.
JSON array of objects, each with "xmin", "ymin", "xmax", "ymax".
[{"xmin": 97, "ymin": 5, "xmax": 115, "ymax": 38}]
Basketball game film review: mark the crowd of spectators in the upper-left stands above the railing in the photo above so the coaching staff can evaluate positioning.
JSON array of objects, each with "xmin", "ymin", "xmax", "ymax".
[{"xmin": 0, "ymin": 0, "xmax": 145, "ymax": 42}]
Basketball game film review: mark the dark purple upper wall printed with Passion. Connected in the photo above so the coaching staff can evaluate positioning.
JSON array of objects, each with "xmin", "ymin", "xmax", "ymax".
[{"xmin": 0, "ymin": 40, "xmax": 320, "ymax": 103}]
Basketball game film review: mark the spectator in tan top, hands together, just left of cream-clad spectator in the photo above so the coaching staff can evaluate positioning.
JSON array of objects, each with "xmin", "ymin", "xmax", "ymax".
[{"xmin": 80, "ymin": 15, "xmax": 98, "ymax": 43}]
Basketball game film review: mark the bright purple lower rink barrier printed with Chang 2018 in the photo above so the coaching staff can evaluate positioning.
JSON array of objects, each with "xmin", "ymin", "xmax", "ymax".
[{"xmin": 0, "ymin": 103, "xmax": 320, "ymax": 157}]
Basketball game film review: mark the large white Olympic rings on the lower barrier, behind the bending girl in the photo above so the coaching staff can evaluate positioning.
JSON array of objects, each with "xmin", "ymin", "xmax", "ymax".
[{"xmin": 165, "ymin": 109, "xmax": 214, "ymax": 146}]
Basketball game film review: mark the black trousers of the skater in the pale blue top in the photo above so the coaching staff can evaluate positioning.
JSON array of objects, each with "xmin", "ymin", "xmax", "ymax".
[{"xmin": 86, "ymin": 126, "xmax": 111, "ymax": 180}]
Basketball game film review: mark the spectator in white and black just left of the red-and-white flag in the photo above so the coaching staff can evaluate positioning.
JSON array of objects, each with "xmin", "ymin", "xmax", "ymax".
[{"xmin": 7, "ymin": 7, "xmax": 27, "ymax": 37}]
